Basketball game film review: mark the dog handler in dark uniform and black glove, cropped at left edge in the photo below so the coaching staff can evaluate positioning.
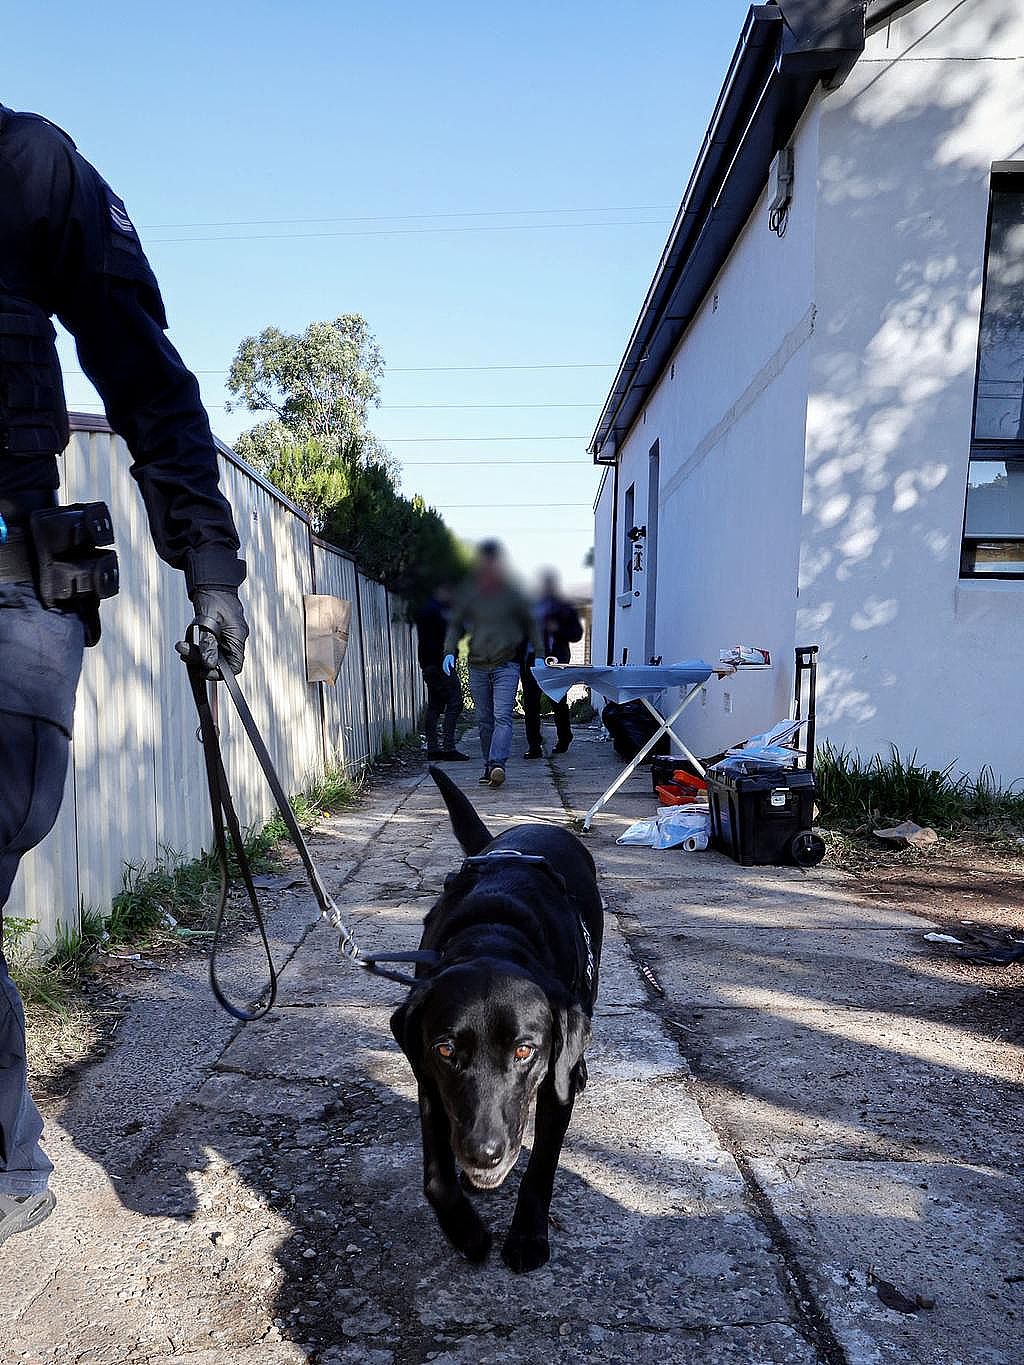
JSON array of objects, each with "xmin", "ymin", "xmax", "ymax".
[{"xmin": 0, "ymin": 105, "xmax": 248, "ymax": 1244}]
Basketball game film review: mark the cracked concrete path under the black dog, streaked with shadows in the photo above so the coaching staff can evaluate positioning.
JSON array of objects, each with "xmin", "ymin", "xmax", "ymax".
[{"xmin": 0, "ymin": 732, "xmax": 1024, "ymax": 1365}]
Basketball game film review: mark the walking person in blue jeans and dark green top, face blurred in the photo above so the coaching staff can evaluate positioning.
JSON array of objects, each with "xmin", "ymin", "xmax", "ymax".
[{"xmin": 442, "ymin": 541, "xmax": 541, "ymax": 786}]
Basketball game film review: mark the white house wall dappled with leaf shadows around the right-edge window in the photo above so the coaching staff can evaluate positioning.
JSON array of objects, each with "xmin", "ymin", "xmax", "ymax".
[{"xmin": 797, "ymin": 0, "xmax": 1024, "ymax": 781}]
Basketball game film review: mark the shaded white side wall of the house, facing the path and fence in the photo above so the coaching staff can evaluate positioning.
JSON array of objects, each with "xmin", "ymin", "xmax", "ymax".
[{"xmin": 598, "ymin": 97, "xmax": 818, "ymax": 753}]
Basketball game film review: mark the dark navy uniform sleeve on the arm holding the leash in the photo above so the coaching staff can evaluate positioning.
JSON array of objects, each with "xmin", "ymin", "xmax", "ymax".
[{"xmin": 27, "ymin": 128, "xmax": 246, "ymax": 591}]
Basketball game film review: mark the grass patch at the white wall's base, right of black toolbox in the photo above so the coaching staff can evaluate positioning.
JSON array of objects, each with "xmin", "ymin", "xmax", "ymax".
[{"xmin": 814, "ymin": 744, "xmax": 1024, "ymax": 833}]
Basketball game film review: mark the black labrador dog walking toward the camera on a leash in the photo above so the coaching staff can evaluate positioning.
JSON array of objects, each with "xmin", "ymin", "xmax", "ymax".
[{"xmin": 390, "ymin": 767, "xmax": 603, "ymax": 1271}]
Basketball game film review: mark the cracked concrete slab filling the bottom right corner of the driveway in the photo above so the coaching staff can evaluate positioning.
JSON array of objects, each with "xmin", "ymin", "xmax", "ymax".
[{"xmin": 754, "ymin": 1159, "xmax": 1024, "ymax": 1365}]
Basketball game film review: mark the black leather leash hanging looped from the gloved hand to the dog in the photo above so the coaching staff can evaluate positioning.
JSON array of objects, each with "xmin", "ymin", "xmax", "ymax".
[{"xmin": 180, "ymin": 624, "xmax": 438, "ymax": 1022}]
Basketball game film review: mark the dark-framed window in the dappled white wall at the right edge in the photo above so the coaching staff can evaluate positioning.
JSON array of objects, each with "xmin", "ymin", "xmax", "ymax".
[{"xmin": 960, "ymin": 168, "xmax": 1024, "ymax": 579}]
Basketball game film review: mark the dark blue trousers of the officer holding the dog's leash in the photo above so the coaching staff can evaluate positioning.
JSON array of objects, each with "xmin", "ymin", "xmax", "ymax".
[{"xmin": 0, "ymin": 584, "xmax": 83, "ymax": 1194}]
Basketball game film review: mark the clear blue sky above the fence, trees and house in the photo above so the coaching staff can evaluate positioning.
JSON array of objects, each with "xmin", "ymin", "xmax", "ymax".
[{"xmin": 8, "ymin": 0, "xmax": 747, "ymax": 587}]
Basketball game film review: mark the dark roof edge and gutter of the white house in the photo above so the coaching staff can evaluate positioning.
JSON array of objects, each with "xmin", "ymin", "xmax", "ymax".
[{"xmin": 590, "ymin": 0, "xmax": 924, "ymax": 464}]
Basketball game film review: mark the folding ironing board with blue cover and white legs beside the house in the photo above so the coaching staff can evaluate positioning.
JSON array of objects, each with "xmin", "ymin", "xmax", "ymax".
[{"xmin": 532, "ymin": 659, "xmax": 736, "ymax": 830}]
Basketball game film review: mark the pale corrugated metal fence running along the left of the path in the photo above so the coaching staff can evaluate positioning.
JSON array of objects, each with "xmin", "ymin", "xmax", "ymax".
[{"xmin": 5, "ymin": 415, "xmax": 423, "ymax": 939}]
